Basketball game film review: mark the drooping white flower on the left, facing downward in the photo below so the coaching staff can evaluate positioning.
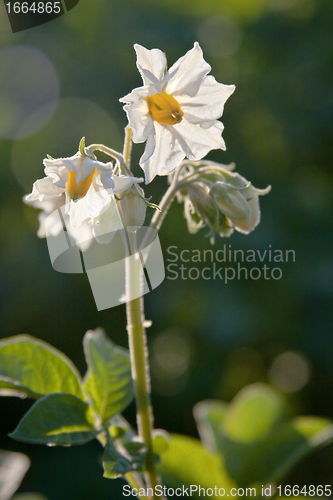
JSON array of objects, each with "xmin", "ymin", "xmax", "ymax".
[{"xmin": 24, "ymin": 144, "xmax": 143, "ymax": 249}]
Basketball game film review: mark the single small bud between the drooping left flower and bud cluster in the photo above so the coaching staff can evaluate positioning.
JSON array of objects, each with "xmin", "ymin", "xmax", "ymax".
[{"xmin": 117, "ymin": 187, "xmax": 147, "ymax": 233}]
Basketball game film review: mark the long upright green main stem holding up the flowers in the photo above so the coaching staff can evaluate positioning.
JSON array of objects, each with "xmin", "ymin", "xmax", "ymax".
[{"xmin": 123, "ymin": 126, "xmax": 159, "ymax": 498}]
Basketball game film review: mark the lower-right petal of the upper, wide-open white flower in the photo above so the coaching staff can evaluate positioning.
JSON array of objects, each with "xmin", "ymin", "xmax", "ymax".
[{"xmin": 173, "ymin": 118, "xmax": 225, "ymax": 160}]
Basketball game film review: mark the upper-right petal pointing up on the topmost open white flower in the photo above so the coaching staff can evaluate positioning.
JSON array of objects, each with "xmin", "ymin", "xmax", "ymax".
[{"xmin": 162, "ymin": 42, "xmax": 211, "ymax": 96}]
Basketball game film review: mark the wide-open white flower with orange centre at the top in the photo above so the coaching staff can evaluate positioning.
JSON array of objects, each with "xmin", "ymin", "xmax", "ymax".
[{"xmin": 120, "ymin": 42, "xmax": 235, "ymax": 183}]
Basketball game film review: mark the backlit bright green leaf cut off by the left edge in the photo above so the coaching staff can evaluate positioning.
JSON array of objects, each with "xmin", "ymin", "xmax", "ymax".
[{"xmin": 0, "ymin": 335, "xmax": 85, "ymax": 399}]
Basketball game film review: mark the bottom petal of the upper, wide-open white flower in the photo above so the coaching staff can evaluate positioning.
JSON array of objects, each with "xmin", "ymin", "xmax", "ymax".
[{"xmin": 140, "ymin": 122, "xmax": 185, "ymax": 184}]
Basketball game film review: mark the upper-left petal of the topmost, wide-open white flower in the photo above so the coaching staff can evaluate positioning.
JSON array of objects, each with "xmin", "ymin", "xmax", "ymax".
[{"xmin": 134, "ymin": 44, "xmax": 167, "ymax": 85}]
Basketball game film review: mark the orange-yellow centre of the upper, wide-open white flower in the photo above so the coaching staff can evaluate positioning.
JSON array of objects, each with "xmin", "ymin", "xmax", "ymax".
[{"xmin": 147, "ymin": 92, "xmax": 184, "ymax": 125}]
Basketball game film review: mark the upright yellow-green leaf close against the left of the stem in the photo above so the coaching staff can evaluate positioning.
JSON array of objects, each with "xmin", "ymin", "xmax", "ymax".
[{"xmin": 83, "ymin": 330, "xmax": 133, "ymax": 425}]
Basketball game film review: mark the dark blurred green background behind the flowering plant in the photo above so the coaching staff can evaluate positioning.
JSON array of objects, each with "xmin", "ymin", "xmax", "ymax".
[{"xmin": 0, "ymin": 0, "xmax": 333, "ymax": 500}]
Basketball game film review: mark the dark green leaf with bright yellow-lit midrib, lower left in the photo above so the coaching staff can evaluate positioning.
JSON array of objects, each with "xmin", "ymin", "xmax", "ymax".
[{"xmin": 9, "ymin": 394, "xmax": 100, "ymax": 446}]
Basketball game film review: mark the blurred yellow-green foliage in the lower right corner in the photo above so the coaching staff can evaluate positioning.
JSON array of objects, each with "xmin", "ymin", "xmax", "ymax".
[{"xmin": 194, "ymin": 384, "xmax": 333, "ymax": 487}]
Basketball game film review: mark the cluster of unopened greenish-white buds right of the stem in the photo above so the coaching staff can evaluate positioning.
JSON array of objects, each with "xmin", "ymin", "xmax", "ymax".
[{"xmin": 169, "ymin": 161, "xmax": 270, "ymax": 243}]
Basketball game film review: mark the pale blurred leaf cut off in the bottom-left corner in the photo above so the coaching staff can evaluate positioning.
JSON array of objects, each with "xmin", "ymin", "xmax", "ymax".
[{"xmin": 0, "ymin": 450, "xmax": 30, "ymax": 500}]
